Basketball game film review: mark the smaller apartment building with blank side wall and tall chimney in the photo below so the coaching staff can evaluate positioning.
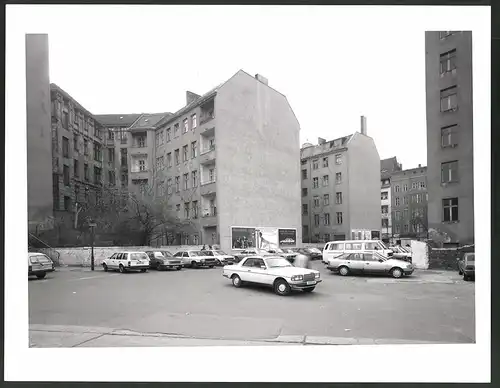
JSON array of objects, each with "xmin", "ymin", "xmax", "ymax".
[{"xmin": 300, "ymin": 117, "xmax": 381, "ymax": 243}]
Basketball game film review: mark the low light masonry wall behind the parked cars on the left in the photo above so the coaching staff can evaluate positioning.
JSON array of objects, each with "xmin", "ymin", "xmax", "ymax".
[{"xmin": 54, "ymin": 245, "xmax": 215, "ymax": 267}]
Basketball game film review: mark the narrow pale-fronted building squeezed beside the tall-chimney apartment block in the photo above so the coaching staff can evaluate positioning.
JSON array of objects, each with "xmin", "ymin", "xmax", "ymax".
[{"xmin": 380, "ymin": 156, "xmax": 403, "ymax": 243}]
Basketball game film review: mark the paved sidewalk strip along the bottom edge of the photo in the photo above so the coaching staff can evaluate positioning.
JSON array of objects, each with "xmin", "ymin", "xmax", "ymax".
[{"xmin": 29, "ymin": 324, "xmax": 448, "ymax": 348}]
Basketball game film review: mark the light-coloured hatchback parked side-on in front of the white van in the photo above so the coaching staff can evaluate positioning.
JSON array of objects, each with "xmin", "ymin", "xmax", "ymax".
[{"xmin": 327, "ymin": 252, "xmax": 414, "ymax": 278}]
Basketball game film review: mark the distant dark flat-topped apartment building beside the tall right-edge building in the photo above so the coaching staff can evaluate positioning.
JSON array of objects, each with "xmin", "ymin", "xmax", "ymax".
[{"xmin": 391, "ymin": 165, "xmax": 428, "ymax": 239}]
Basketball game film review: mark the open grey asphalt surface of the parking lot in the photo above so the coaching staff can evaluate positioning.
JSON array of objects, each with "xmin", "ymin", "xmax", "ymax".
[{"xmin": 29, "ymin": 262, "xmax": 475, "ymax": 346}]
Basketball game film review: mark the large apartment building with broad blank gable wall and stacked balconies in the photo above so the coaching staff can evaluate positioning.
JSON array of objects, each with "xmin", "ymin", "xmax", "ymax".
[{"xmin": 153, "ymin": 70, "xmax": 302, "ymax": 251}]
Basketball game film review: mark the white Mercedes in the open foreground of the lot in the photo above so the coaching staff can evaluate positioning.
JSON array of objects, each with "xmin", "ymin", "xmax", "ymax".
[{"xmin": 222, "ymin": 256, "xmax": 321, "ymax": 295}]
